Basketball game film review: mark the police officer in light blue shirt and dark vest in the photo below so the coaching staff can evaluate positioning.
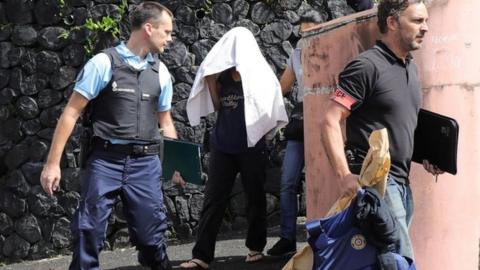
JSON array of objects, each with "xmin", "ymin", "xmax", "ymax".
[{"xmin": 41, "ymin": 1, "xmax": 177, "ymax": 270}]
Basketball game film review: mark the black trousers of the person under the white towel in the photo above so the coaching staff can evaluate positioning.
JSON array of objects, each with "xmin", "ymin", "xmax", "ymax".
[{"xmin": 192, "ymin": 147, "xmax": 267, "ymax": 263}]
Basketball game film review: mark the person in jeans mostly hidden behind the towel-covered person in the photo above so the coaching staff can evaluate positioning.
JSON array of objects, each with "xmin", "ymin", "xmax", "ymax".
[{"xmin": 267, "ymin": 10, "xmax": 323, "ymax": 256}]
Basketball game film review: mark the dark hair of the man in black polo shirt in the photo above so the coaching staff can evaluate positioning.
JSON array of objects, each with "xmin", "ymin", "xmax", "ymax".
[{"xmin": 377, "ymin": 0, "xmax": 426, "ymax": 34}]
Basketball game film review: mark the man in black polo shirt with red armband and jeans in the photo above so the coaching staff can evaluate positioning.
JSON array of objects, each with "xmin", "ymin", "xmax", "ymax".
[{"xmin": 321, "ymin": 0, "xmax": 441, "ymax": 258}]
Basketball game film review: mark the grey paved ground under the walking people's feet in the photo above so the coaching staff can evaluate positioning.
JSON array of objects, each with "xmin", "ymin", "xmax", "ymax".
[{"xmin": 0, "ymin": 225, "xmax": 305, "ymax": 270}]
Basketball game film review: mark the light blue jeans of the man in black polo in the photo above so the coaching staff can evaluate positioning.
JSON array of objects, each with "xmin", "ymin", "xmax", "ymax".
[{"xmin": 385, "ymin": 175, "xmax": 414, "ymax": 259}]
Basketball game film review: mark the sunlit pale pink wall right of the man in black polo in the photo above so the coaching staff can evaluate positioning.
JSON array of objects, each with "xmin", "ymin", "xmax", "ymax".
[{"xmin": 410, "ymin": 0, "xmax": 480, "ymax": 270}]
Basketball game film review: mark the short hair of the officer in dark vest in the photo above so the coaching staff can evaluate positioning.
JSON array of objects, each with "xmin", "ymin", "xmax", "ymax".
[{"xmin": 129, "ymin": 1, "xmax": 173, "ymax": 30}]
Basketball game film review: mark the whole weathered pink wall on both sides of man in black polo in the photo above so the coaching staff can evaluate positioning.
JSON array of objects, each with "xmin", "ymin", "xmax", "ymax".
[{"xmin": 302, "ymin": 0, "xmax": 480, "ymax": 270}]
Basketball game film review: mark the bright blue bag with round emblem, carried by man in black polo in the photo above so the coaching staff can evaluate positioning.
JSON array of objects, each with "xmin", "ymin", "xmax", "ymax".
[{"xmin": 306, "ymin": 190, "xmax": 416, "ymax": 270}]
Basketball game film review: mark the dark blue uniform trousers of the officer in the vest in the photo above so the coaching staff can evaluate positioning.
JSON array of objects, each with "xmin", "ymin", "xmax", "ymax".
[{"xmin": 70, "ymin": 151, "xmax": 167, "ymax": 270}]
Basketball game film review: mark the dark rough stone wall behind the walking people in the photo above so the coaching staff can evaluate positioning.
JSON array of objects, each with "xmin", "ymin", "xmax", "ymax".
[{"xmin": 0, "ymin": 0, "xmax": 352, "ymax": 263}]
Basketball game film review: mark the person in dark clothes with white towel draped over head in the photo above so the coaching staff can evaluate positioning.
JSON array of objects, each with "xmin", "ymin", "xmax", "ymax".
[{"xmin": 180, "ymin": 27, "xmax": 288, "ymax": 269}]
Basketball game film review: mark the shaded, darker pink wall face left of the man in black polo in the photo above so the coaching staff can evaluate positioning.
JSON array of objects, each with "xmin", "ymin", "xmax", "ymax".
[{"xmin": 301, "ymin": 10, "xmax": 377, "ymax": 219}]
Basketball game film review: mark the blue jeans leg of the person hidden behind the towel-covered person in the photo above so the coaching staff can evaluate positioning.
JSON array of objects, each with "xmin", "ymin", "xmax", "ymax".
[{"xmin": 280, "ymin": 140, "xmax": 305, "ymax": 241}]
